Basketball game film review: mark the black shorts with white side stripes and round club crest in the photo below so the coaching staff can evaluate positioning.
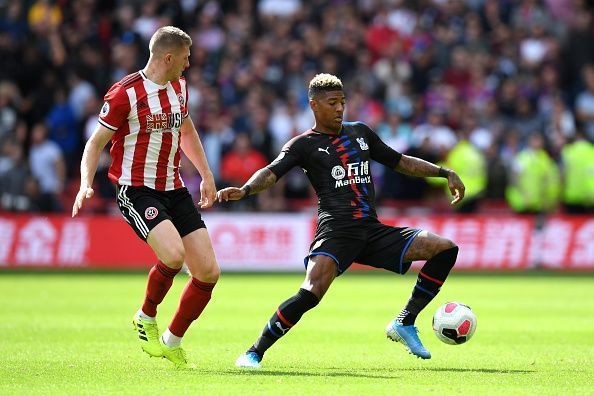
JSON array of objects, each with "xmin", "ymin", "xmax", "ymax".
[{"xmin": 117, "ymin": 186, "xmax": 206, "ymax": 241}]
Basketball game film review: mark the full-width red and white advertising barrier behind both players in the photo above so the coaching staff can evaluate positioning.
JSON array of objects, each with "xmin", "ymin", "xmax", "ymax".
[{"xmin": 0, "ymin": 213, "xmax": 594, "ymax": 271}]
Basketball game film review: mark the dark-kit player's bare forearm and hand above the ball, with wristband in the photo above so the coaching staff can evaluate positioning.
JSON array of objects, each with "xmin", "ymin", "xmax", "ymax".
[{"xmin": 394, "ymin": 155, "xmax": 466, "ymax": 205}]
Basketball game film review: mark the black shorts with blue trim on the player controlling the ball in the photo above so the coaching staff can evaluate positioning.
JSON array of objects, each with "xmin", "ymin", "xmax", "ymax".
[{"xmin": 304, "ymin": 220, "xmax": 422, "ymax": 275}]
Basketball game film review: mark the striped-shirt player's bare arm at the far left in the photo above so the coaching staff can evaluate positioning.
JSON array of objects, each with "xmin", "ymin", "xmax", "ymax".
[{"xmin": 72, "ymin": 124, "xmax": 114, "ymax": 217}]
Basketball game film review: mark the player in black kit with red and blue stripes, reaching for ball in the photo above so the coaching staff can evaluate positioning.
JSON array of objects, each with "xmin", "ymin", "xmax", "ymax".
[{"xmin": 217, "ymin": 74, "xmax": 464, "ymax": 368}]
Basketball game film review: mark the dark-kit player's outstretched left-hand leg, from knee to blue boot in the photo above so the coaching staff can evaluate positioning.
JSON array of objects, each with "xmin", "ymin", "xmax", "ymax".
[{"xmin": 235, "ymin": 254, "xmax": 338, "ymax": 368}]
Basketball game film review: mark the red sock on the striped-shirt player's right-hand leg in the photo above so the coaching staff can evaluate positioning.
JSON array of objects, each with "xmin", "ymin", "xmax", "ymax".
[{"xmin": 169, "ymin": 278, "xmax": 216, "ymax": 337}]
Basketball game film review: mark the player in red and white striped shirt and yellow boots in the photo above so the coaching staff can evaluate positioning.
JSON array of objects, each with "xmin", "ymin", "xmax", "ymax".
[{"xmin": 72, "ymin": 26, "xmax": 220, "ymax": 368}]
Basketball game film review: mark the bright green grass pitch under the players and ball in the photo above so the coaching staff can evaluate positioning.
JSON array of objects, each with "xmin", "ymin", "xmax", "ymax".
[{"xmin": 0, "ymin": 272, "xmax": 594, "ymax": 395}]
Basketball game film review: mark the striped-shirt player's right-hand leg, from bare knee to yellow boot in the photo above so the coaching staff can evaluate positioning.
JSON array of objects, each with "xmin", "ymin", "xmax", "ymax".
[{"xmin": 161, "ymin": 228, "xmax": 220, "ymax": 367}]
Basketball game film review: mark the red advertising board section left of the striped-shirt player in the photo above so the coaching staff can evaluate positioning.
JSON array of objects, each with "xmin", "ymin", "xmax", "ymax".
[{"xmin": 0, "ymin": 216, "xmax": 155, "ymax": 268}]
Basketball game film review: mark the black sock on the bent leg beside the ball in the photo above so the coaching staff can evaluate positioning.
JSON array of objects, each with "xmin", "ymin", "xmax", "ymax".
[{"xmin": 396, "ymin": 246, "xmax": 458, "ymax": 326}]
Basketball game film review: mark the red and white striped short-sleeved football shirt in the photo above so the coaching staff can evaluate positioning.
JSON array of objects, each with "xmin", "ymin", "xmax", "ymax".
[{"xmin": 99, "ymin": 70, "xmax": 188, "ymax": 191}]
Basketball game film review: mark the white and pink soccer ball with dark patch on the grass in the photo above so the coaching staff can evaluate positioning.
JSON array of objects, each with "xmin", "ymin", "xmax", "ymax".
[{"xmin": 433, "ymin": 302, "xmax": 476, "ymax": 345}]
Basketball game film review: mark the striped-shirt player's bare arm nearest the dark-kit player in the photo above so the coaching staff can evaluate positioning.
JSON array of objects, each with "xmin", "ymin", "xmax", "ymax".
[{"xmin": 180, "ymin": 117, "xmax": 217, "ymax": 208}]
